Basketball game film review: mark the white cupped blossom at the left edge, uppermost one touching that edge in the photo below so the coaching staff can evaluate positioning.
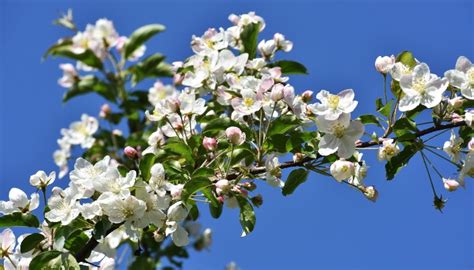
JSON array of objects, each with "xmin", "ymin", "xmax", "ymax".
[{"xmin": 0, "ymin": 188, "xmax": 39, "ymax": 215}]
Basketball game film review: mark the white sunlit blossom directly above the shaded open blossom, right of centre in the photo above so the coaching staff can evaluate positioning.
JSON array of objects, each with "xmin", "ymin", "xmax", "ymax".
[{"xmin": 308, "ymin": 89, "xmax": 358, "ymax": 120}]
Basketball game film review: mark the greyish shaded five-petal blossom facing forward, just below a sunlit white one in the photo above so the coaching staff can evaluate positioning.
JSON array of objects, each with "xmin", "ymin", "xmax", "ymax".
[{"xmin": 316, "ymin": 113, "xmax": 364, "ymax": 158}]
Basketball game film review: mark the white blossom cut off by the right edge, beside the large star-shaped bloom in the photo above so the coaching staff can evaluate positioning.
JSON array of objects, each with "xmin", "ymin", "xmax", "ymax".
[{"xmin": 444, "ymin": 56, "xmax": 474, "ymax": 100}]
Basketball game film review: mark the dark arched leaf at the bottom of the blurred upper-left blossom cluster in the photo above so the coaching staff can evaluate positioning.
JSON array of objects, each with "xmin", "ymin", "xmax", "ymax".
[{"xmin": 63, "ymin": 76, "xmax": 116, "ymax": 103}]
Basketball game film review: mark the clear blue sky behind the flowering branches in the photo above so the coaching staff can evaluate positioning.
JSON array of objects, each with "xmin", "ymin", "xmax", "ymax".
[{"xmin": 0, "ymin": 0, "xmax": 474, "ymax": 270}]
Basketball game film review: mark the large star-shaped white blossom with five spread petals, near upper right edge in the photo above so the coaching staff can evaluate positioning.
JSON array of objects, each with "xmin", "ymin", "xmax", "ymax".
[{"xmin": 399, "ymin": 63, "xmax": 448, "ymax": 112}]
